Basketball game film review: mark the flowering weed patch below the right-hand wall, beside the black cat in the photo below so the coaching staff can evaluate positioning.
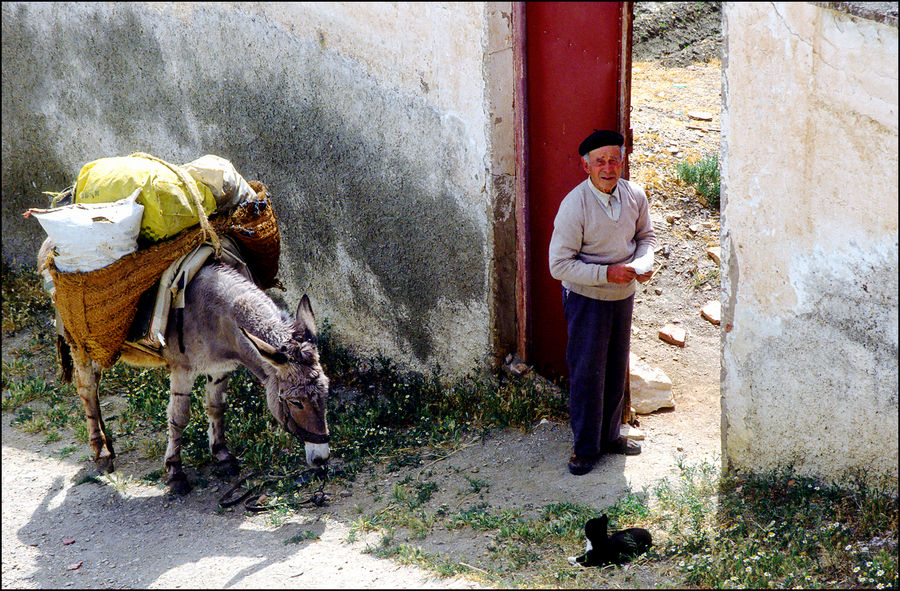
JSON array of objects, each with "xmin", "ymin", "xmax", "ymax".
[{"xmin": 654, "ymin": 465, "xmax": 898, "ymax": 589}]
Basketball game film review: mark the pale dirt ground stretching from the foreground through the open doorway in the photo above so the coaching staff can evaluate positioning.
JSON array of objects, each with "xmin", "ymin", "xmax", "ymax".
[{"xmin": 2, "ymin": 3, "xmax": 721, "ymax": 588}]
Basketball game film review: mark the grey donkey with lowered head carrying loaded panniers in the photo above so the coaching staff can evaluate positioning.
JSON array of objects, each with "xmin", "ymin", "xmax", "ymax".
[{"xmin": 38, "ymin": 239, "xmax": 329, "ymax": 494}]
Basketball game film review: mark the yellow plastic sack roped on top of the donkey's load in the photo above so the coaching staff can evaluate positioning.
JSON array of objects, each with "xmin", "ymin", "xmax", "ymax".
[{"xmin": 75, "ymin": 156, "xmax": 216, "ymax": 242}]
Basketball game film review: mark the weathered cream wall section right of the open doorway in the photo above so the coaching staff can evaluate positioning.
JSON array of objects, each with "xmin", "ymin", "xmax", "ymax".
[{"xmin": 722, "ymin": 2, "xmax": 898, "ymax": 486}]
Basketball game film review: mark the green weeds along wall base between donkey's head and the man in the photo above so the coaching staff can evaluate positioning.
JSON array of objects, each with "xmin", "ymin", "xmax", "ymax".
[{"xmin": 319, "ymin": 319, "xmax": 568, "ymax": 472}]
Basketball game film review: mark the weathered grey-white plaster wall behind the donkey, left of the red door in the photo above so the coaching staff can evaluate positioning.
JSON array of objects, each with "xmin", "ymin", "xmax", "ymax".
[{"xmin": 2, "ymin": 2, "xmax": 512, "ymax": 372}]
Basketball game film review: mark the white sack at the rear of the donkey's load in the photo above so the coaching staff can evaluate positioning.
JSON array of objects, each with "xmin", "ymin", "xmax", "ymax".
[{"xmin": 28, "ymin": 189, "xmax": 144, "ymax": 273}]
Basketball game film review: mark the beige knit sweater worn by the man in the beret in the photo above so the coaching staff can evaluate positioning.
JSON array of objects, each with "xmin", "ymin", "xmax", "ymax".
[{"xmin": 550, "ymin": 178, "xmax": 656, "ymax": 300}]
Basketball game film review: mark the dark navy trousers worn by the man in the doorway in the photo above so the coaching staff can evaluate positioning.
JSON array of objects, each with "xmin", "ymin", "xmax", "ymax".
[{"xmin": 563, "ymin": 288, "xmax": 634, "ymax": 455}]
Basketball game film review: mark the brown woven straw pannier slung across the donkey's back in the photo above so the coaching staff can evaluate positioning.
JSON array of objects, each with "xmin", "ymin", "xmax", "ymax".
[{"xmin": 49, "ymin": 181, "xmax": 281, "ymax": 369}]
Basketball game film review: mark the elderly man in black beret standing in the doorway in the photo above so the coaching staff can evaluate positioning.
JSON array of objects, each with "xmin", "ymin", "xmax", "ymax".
[{"xmin": 550, "ymin": 130, "xmax": 656, "ymax": 475}]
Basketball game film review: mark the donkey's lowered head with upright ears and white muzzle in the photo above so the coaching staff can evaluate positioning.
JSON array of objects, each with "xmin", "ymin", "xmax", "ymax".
[{"xmin": 241, "ymin": 294, "xmax": 329, "ymax": 466}]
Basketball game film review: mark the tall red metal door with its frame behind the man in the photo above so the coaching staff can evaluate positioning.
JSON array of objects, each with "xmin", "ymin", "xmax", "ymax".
[{"xmin": 513, "ymin": 2, "xmax": 633, "ymax": 377}]
